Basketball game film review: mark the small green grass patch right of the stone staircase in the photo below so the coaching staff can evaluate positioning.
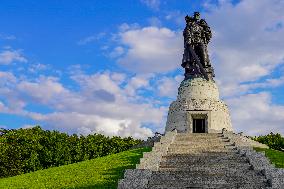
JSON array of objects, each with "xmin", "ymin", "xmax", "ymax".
[{"xmin": 254, "ymin": 148, "xmax": 284, "ymax": 168}]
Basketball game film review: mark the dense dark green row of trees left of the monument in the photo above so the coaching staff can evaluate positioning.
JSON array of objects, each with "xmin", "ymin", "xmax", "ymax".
[{"xmin": 0, "ymin": 126, "xmax": 142, "ymax": 178}]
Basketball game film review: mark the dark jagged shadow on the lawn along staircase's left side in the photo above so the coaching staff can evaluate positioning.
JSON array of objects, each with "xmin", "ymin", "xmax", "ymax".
[{"xmin": 69, "ymin": 148, "xmax": 151, "ymax": 189}]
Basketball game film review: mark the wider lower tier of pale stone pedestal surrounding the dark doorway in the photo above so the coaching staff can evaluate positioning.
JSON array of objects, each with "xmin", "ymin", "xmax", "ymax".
[{"xmin": 166, "ymin": 99, "xmax": 233, "ymax": 132}]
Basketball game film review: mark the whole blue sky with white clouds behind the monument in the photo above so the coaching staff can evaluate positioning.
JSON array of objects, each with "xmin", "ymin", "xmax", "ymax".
[{"xmin": 0, "ymin": 0, "xmax": 284, "ymax": 138}]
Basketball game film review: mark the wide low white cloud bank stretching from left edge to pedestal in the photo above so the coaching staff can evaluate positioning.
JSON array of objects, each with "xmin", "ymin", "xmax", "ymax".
[{"xmin": 0, "ymin": 71, "xmax": 166, "ymax": 138}]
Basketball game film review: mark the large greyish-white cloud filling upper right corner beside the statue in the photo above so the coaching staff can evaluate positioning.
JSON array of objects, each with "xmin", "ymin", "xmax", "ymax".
[{"xmin": 205, "ymin": 0, "xmax": 284, "ymax": 91}]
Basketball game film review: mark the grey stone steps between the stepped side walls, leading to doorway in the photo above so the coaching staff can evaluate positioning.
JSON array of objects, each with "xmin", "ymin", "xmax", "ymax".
[{"xmin": 147, "ymin": 133, "xmax": 268, "ymax": 189}]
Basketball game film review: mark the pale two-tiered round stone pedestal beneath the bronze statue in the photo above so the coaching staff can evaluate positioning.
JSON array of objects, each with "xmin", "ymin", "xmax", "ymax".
[{"xmin": 166, "ymin": 78, "xmax": 233, "ymax": 133}]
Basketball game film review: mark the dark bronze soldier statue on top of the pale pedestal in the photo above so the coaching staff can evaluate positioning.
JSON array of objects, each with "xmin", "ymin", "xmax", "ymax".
[{"xmin": 182, "ymin": 12, "xmax": 214, "ymax": 80}]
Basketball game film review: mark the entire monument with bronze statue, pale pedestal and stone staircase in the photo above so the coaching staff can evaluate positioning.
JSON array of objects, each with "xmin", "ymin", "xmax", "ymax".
[{"xmin": 118, "ymin": 12, "xmax": 284, "ymax": 189}]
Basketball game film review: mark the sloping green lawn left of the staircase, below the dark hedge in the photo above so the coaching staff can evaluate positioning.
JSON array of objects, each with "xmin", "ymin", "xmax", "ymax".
[{"xmin": 0, "ymin": 148, "xmax": 151, "ymax": 189}]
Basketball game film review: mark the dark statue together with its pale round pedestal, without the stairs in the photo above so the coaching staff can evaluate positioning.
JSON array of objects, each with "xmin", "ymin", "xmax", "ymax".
[{"xmin": 165, "ymin": 12, "xmax": 233, "ymax": 133}]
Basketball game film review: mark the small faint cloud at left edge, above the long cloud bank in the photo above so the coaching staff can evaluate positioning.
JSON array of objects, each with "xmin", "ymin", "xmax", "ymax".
[{"xmin": 0, "ymin": 50, "xmax": 27, "ymax": 65}]
